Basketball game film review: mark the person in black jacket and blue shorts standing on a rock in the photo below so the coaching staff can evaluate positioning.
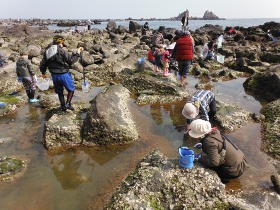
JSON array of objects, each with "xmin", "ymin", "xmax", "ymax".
[{"xmin": 40, "ymin": 35, "xmax": 83, "ymax": 111}]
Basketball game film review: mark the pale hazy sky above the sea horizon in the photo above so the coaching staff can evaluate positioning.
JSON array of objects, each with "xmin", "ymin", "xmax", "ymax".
[{"xmin": 0, "ymin": 0, "xmax": 280, "ymax": 19}]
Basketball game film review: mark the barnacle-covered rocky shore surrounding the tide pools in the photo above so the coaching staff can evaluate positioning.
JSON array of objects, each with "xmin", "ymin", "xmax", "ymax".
[{"xmin": 0, "ymin": 21, "xmax": 280, "ymax": 209}]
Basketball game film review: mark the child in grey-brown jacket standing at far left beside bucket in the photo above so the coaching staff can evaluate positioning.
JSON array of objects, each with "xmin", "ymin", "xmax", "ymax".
[{"xmin": 16, "ymin": 49, "xmax": 39, "ymax": 103}]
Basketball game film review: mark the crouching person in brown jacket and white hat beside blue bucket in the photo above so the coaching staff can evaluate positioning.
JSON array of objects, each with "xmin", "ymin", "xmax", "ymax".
[{"xmin": 189, "ymin": 119, "xmax": 249, "ymax": 183}]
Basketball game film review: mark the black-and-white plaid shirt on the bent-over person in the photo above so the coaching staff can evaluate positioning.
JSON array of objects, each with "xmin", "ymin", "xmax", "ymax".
[{"xmin": 188, "ymin": 90, "xmax": 215, "ymax": 121}]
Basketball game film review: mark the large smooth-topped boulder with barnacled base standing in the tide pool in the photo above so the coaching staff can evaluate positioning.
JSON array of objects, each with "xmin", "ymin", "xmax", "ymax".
[{"xmin": 83, "ymin": 85, "xmax": 138, "ymax": 145}]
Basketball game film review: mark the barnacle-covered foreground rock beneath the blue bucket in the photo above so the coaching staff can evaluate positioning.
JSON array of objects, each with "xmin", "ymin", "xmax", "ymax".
[{"xmin": 105, "ymin": 151, "xmax": 270, "ymax": 209}]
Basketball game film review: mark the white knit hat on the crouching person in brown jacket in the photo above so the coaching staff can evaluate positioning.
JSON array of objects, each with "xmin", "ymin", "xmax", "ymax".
[{"xmin": 189, "ymin": 119, "xmax": 211, "ymax": 138}]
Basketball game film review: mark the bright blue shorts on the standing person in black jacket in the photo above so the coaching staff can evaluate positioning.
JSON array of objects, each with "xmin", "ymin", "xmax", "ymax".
[{"xmin": 52, "ymin": 72, "xmax": 75, "ymax": 94}]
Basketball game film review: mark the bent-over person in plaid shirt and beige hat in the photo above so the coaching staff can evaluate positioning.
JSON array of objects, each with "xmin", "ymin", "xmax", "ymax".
[{"xmin": 182, "ymin": 90, "xmax": 216, "ymax": 134}]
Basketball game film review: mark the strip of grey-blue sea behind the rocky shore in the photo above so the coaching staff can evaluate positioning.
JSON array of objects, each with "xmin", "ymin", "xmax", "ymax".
[{"xmin": 48, "ymin": 18, "xmax": 280, "ymax": 31}]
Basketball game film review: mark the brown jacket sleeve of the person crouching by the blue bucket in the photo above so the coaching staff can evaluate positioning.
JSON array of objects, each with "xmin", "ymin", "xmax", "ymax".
[{"xmin": 199, "ymin": 138, "xmax": 220, "ymax": 168}]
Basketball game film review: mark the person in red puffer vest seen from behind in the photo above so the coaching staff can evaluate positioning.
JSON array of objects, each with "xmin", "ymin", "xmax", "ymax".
[{"xmin": 174, "ymin": 31, "xmax": 194, "ymax": 87}]
